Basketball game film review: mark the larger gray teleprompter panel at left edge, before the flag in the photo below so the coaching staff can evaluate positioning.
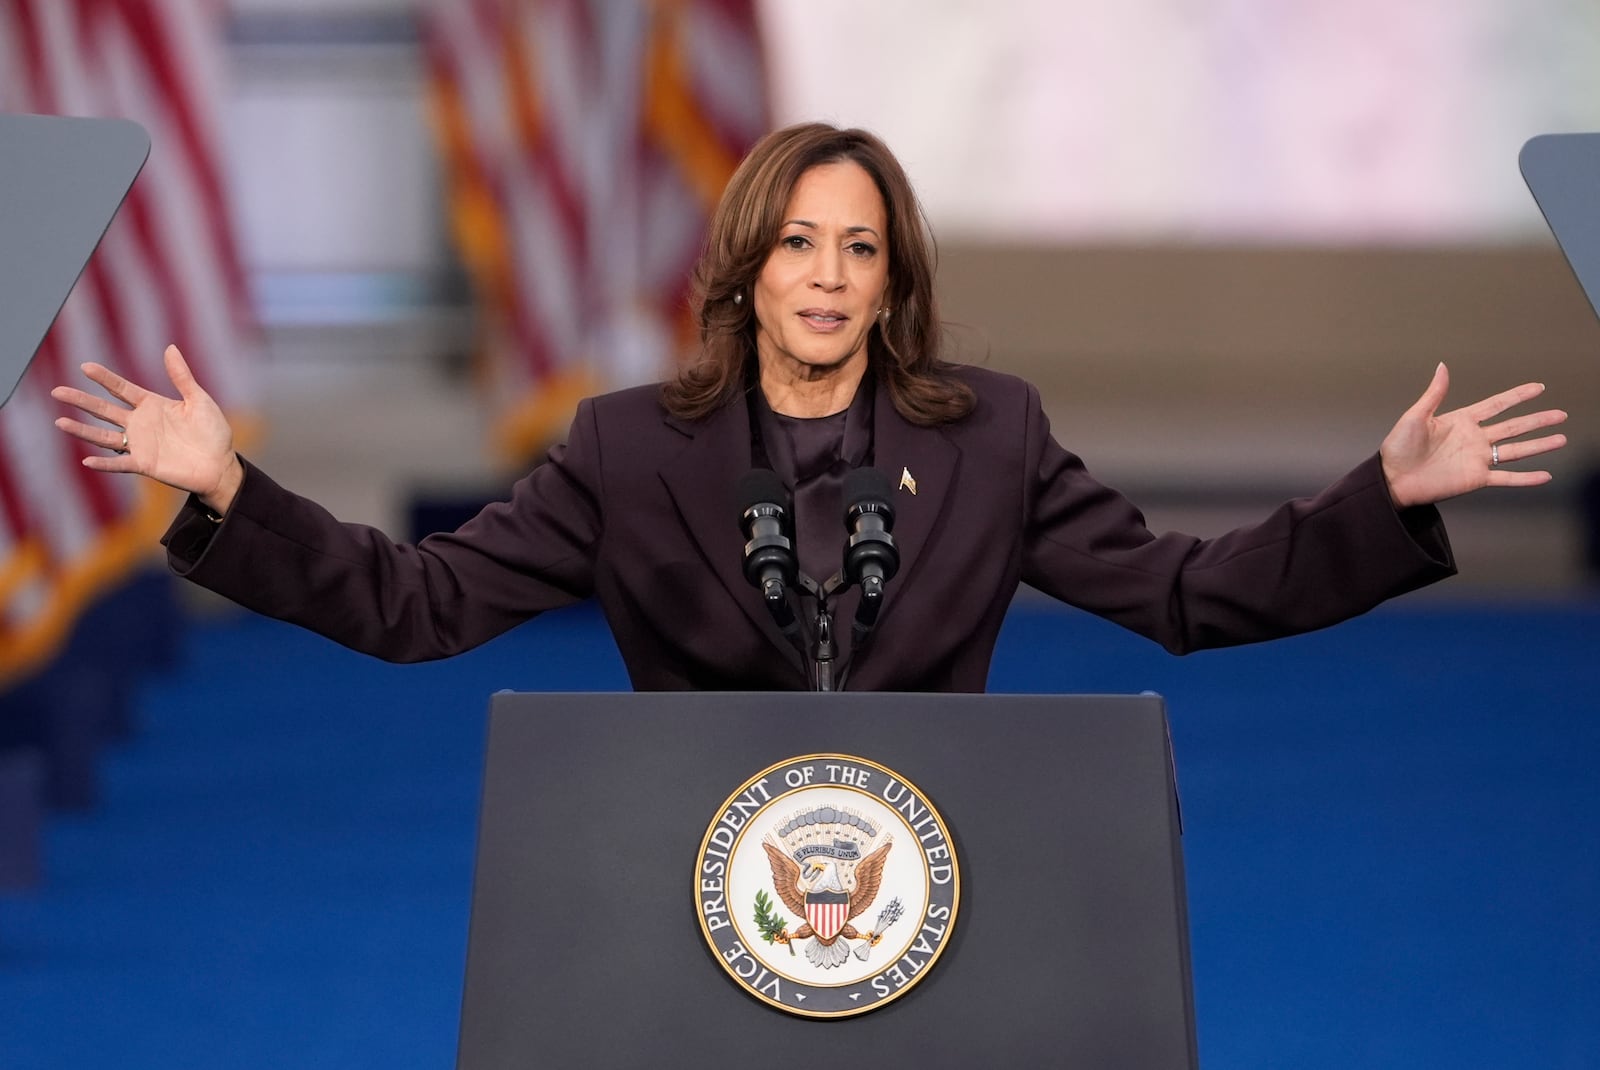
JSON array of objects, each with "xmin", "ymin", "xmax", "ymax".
[{"xmin": 0, "ymin": 115, "xmax": 150, "ymax": 405}]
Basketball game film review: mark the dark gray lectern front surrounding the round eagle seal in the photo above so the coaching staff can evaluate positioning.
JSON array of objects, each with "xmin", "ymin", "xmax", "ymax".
[{"xmin": 458, "ymin": 694, "xmax": 1197, "ymax": 1070}]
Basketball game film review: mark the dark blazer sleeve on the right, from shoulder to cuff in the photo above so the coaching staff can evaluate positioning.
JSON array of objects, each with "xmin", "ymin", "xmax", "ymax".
[{"xmin": 1022, "ymin": 387, "xmax": 1456, "ymax": 654}]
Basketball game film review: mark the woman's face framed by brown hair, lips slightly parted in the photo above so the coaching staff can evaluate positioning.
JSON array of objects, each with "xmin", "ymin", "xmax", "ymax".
[{"xmin": 755, "ymin": 160, "xmax": 890, "ymax": 379}]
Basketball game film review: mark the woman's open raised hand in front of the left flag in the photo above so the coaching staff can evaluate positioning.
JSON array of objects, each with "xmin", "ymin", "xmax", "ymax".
[{"xmin": 50, "ymin": 345, "xmax": 245, "ymax": 513}]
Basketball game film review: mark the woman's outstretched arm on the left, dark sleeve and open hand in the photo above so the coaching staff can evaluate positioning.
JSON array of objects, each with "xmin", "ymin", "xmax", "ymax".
[{"xmin": 53, "ymin": 347, "xmax": 602, "ymax": 661}]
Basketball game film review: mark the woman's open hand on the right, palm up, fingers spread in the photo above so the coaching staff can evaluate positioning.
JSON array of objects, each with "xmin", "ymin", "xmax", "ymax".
[{"xmin": 1378, "ymin": 365, "xmax": 1566, "ymax": 509}]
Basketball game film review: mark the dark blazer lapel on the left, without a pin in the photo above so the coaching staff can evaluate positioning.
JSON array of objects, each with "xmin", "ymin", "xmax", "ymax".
[{"xmin": 661, "ymin": 391, "xmax": 805, "ymax": 673}]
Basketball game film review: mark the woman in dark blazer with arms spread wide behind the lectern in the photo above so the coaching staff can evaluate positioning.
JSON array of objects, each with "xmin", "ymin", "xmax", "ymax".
[{"xmin": 54, "ymin": 123, "xmax": 1565, "ymax": 691}]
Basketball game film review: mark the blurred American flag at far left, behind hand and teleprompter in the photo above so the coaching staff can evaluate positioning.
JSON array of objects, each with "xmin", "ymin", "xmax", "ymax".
[{"xmin": 0, "ymin": 0, "xmax": 258, "ymax": 685}]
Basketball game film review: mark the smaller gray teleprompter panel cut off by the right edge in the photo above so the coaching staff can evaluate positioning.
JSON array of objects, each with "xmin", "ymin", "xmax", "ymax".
[{"xmin": 1517, "ymin": 134, "xmax": 1600, "ymax": 327}]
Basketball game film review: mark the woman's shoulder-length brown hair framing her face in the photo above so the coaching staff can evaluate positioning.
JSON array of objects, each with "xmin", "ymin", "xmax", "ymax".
[{"xmin": 662, "ymin": 123, "xmax": 974, "ymax": 427}]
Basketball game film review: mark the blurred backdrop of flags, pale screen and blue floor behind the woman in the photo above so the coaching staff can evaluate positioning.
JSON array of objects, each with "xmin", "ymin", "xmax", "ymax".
[{"xmin": 0, "ymin": 0, "xmax": 1600, "ymax": 1067}]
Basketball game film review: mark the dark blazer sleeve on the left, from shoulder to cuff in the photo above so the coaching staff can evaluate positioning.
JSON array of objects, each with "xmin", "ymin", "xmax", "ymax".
[{"xmin": 162, "ymin": 401, "xmax": 603, "ymax": 662}]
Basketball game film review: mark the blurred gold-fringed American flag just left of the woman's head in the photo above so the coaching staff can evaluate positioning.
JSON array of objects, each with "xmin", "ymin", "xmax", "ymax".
[{"xmin": 422, "ymin": 0, "xmax": 768, "ymax": 459}]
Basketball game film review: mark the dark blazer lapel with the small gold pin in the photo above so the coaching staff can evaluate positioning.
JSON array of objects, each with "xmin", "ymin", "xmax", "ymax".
[{"xmin": 869, "ymin": 382, "xmax": 962, "ymax": 630}]
